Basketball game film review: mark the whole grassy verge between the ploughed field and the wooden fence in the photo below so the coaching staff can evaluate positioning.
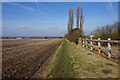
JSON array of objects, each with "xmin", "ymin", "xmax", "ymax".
[{"xmin": 47, "ymin": 40, "xmax": 118, "ymax": 78}]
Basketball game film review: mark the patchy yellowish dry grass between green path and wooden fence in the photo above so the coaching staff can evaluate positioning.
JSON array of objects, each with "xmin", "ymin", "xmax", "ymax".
[{"xmin": 72, "ymin": 45, "xmax": 118, "ymax": 78}]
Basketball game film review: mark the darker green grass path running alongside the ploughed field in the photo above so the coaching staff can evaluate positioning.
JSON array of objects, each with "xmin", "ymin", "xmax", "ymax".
[{"xmin": 48, "ymin": 40, "xmax": 74, "ymax": 78}]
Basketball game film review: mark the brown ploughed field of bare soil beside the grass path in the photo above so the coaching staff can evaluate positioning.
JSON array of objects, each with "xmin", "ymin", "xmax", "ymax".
[{"xmin": 2, "ymin": 39, "xmax": 62, "ymax": 78}]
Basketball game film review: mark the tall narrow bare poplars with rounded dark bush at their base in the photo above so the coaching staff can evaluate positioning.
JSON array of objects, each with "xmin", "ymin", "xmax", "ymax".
[{"xmin": 65, "ymin": 5, "xmax": 84, "ymax": 44}]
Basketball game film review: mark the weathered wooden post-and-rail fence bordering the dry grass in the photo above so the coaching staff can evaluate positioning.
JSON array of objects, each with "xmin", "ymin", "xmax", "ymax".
[{"xmin": 79, "ymin": 38, "xmax": 120, "ymax": 63}]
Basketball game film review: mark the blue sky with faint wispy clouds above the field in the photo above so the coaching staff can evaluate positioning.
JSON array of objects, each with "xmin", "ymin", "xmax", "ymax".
[{"xmin": 2, "ymin": 0, "xmax": 118, "ymax": 37}]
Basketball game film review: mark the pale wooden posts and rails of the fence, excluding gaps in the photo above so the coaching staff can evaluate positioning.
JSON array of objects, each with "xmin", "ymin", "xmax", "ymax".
[{"xmin": 79, "ymin": 38, "xmax": 120, "ymax": 63}]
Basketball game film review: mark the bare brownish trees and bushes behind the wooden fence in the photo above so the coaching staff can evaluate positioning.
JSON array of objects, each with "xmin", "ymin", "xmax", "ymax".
[{"xmin": 93, "ymin": 22, "xmax": 120, "ymax": 40}]
